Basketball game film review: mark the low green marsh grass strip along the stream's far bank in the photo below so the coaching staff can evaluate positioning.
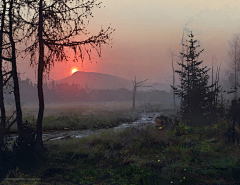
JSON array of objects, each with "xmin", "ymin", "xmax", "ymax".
[{"xmin": 7, "ymin": 107, "xmax": 139, "ymax": 132}]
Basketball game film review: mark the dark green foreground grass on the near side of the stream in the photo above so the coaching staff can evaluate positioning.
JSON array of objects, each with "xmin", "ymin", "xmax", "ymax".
[{"xmin": 3, "ymin": 110, "xmax": 240, "ymax": 185}]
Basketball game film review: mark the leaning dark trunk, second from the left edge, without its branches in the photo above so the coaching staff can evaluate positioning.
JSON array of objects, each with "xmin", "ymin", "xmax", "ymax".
[{"xmin": 9, "ymin": 0, "xmax": 24, "ymax": 138}]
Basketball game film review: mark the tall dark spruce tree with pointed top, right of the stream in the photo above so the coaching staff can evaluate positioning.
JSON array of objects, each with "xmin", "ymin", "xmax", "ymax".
[{"xmin": 171, "ymin": 33, "xmax": 218, "ymax": 124}]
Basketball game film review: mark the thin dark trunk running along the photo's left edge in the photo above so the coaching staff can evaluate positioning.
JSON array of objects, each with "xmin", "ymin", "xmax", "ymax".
[{"xmin": 0, "ymin": 0, "xmax": 6, "ymax": 147}]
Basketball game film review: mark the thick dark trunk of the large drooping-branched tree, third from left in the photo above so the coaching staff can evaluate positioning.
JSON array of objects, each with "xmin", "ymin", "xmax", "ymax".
[{"xmin": 36, "ymin": 0, "xmax": 44, "ymax": 148}]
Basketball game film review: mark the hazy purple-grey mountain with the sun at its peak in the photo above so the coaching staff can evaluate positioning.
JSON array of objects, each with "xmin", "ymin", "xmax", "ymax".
[{"xmin": 52, "ymin": 71, "xmax": 170, "ymax": 91}]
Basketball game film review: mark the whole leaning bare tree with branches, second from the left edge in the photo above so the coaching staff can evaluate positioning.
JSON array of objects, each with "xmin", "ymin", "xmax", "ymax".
[{"xmin": 1, "ymin": 0, "xmax": 24, "ymax": 142}]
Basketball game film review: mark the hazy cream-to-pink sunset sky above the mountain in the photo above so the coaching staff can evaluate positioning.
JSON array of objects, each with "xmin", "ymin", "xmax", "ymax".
[{"xmin": 18, "ymin": 0, "xmax": 240, "ymax": 84}]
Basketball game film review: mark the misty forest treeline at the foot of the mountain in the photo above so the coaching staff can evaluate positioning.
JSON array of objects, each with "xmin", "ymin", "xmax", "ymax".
[{"xmin": 5, "ymin": 78, "xmax": 171, "ymax": 104}]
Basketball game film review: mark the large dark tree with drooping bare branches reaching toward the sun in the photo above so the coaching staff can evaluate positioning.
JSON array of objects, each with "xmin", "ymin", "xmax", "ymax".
[{"xmin": 20, "ymin": 0, "xmax": 114, "ymax": 151}]
